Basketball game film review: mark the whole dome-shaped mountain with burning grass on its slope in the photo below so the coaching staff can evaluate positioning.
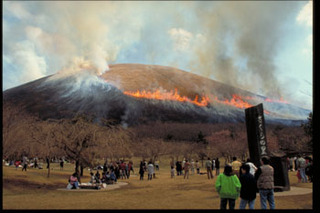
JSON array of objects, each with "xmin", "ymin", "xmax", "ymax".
[{"xmin": 3, "ymin": 64, "xmax": 309, "ymax": 125}]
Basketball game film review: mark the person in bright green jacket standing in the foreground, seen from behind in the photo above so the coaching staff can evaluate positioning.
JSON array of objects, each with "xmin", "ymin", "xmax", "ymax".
[{"xmin": 215, "ymin": 165, "xmax": 241, "ymax": 209}]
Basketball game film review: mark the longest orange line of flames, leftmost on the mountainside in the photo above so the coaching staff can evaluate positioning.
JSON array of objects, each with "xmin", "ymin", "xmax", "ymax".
[{"xmin": 123, "ymin": 88, "xmax": 210, "ymax": 106}]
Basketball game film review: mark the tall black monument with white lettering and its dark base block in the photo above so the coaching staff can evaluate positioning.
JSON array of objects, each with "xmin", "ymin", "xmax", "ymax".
[{"xmin": 245, "ymin": 104, "xmax": 290, "ymax": 191}]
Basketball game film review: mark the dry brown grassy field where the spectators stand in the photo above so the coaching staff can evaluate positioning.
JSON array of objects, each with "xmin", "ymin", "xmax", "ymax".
[{"xmin": 3, "ymin": 160, "xmax": 312, "ymax": 209}]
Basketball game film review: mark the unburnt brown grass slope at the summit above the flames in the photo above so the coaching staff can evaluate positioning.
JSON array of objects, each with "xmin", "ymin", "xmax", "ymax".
[{"xmin": 102, "ymin": 64, "xmax": 254, "ymax": 99}]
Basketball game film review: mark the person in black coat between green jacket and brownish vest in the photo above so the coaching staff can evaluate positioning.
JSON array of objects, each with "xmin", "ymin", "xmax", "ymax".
[{"xmin": 239, "ymin": 164, "xmax": 257, "ymax": 209}]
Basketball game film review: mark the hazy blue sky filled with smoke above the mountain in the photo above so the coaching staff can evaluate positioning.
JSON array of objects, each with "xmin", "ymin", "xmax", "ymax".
[{"xmin": 2, "ymin": 1, "xmax": 313, "ymax": 109}]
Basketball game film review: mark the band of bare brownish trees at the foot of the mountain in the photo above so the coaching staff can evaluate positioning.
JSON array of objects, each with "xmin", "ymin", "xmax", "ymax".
[{"xmin": 3, "ymin": 104, "xmax": 312, "ymax": 176}]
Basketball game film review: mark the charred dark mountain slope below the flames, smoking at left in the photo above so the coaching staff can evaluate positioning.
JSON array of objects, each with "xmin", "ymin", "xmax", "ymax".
[{"xmin": 3, "ymin": 76, "xmax": 243, "ymax": 125}]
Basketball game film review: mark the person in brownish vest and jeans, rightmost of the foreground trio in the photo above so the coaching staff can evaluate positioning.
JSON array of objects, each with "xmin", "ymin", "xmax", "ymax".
[{"xmin": 255, "ymin": 156, "xmax": 275, "ymax": 209}]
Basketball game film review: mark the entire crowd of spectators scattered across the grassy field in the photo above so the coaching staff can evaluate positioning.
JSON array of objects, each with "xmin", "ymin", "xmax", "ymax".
[{"xmin": 3, "ymin": 152, "xmax": 313, "ymax": 209}]
